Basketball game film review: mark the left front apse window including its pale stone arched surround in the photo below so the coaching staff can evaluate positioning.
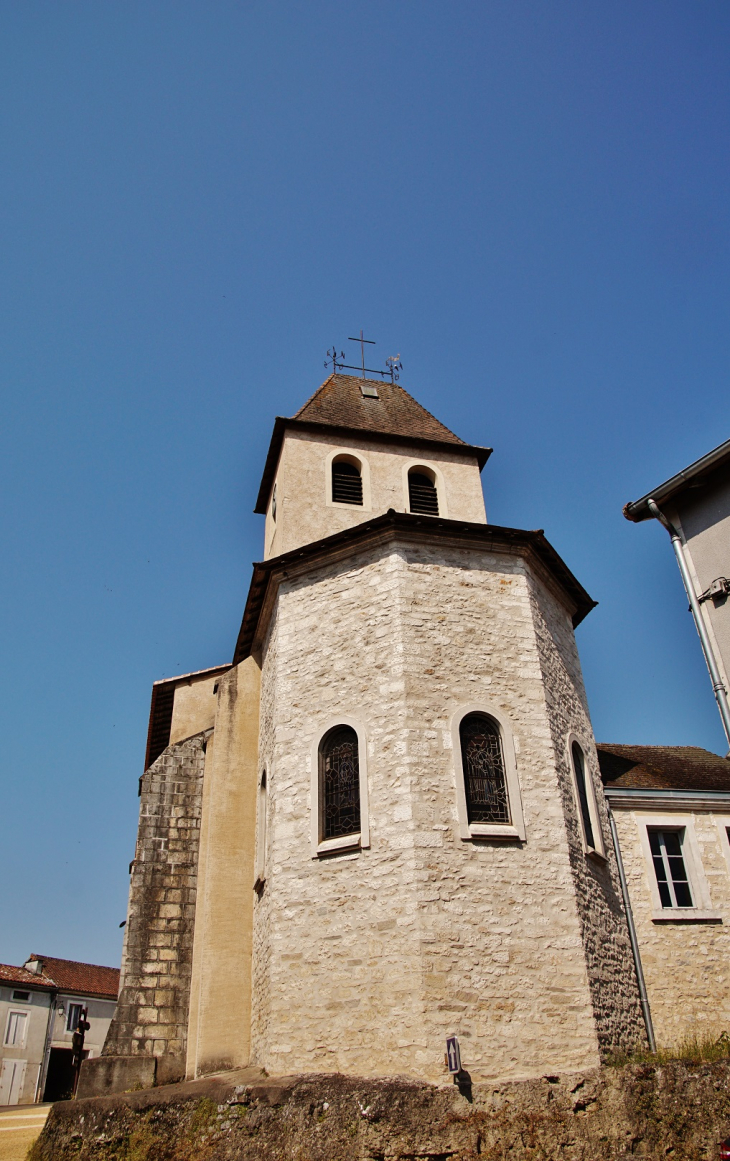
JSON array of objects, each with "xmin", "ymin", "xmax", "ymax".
[{"xmin": 312, "ymin": 717, "xmax": 369, "ymax": 858}]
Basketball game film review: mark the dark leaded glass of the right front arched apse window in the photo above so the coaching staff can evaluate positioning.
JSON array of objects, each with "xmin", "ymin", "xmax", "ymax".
[{"xmin": 458, "ymin": 714, "xmax": 512, "ymax": 825}]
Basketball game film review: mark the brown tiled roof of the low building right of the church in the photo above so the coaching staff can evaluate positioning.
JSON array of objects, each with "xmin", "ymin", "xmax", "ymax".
[{"xmin": 598, "ymin": 743, "xmax": 730, "ymax": 791}]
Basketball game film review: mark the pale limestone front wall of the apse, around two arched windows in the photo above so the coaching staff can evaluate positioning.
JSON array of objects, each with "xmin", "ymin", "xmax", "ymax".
[{"xmin": 252, "ymin": 543, "xmax": 630, "ymax": 1079}]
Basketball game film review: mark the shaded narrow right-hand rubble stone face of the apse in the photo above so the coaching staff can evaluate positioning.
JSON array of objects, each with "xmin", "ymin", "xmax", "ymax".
[{"xmin": 530, "ymin": 583, "xmax": 645, "ymax": 1054}]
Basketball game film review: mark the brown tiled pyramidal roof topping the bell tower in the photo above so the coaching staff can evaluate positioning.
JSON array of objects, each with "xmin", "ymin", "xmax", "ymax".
[{"xmin": 292, "ymin": 375, "xmax": 468, "ymax": 447}]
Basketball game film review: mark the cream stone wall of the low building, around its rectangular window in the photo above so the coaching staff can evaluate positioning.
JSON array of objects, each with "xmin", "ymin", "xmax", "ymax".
[{"xmin": 614, "ymin": 807, "xmax": 730, "ymax": 1046}]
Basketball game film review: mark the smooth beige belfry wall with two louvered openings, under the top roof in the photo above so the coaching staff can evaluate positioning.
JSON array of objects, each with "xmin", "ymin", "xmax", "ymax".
[{"xmin": 265, "ymin": 430, "xmax": 486, "ymax": 557}]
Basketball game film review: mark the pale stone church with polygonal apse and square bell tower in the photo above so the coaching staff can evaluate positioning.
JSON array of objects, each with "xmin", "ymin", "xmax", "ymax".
[{"xmin": 96, "ymin": 374, "xmax": 644, "ymax": 1095}]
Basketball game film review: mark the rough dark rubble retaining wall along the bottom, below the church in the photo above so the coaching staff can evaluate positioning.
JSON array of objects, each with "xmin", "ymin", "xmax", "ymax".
[{"xmin": 29, "ymin": 1061, "xmax": 730, "ymax": 1161}]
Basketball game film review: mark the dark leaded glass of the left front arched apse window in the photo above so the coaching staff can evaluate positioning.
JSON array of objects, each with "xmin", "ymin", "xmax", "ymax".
[{"xmin": 319, "ymin": 726, "xmax": 360, "ymax": 841}]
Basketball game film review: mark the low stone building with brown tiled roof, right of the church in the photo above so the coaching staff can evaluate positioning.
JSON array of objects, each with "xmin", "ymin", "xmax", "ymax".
[{"xmin": 598, "ymin": 744, "xmax": 730, "ymax": 1046}]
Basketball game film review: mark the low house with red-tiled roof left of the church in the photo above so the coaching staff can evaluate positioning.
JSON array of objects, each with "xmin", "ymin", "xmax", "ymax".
[{"xmin": 0, "ymin": 954, "xmax": 120, "ymax": 1105}]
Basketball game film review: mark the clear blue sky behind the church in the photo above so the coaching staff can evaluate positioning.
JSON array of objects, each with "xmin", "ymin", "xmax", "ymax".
[{"xmin": 0, "ymin": 0, "xmax": 730, "ymax": 964}]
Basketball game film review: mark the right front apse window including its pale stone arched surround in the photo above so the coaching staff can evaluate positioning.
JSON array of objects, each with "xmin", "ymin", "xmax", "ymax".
[{"xmin": 451, "ymin": 704, "xmax": 526, "ymax": 841}]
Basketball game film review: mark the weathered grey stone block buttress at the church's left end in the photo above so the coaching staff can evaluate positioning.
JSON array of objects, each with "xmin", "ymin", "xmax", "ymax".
[{"xmin": 102, "ymin": 730, "xmax": 210, "ymax": 1081}]
